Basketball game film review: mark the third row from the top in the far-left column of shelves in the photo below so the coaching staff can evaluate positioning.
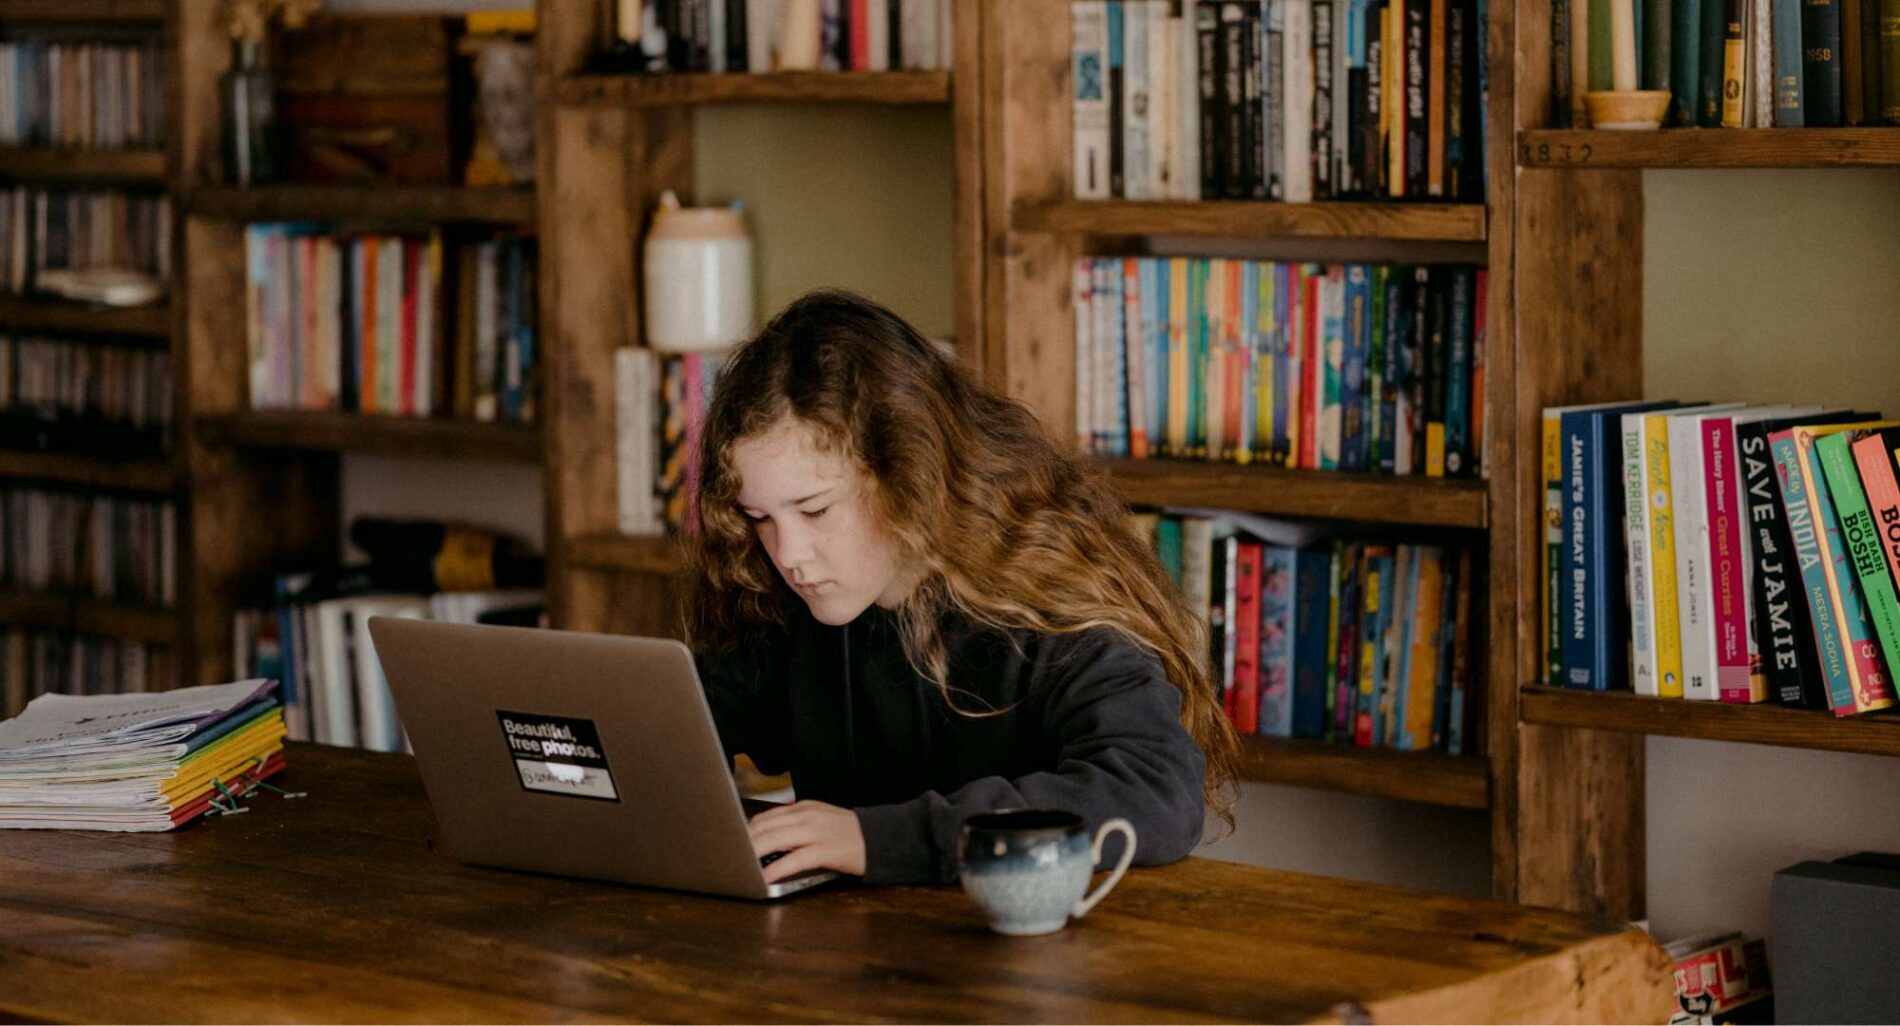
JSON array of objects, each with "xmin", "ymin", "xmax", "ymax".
[{"xmin": 0, "ymin": 334, "xmax": 173, "ymax": 458}]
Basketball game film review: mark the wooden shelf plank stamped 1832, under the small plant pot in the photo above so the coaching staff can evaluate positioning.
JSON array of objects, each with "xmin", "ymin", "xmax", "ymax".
[{"xmin": 1518, "ymin": 127, "xmax": 1900, "ymax": 167}]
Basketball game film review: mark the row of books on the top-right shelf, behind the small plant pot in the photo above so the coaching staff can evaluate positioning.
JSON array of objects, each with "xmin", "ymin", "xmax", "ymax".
[{"xmin": 1550, "ymin": 0, "xmax": 1900, "ymax": 127}]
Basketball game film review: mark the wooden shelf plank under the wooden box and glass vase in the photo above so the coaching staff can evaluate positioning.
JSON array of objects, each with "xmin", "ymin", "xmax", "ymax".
[{"xmin": 186, "ymin": 184, "xmax": 534, "ymax": 224}]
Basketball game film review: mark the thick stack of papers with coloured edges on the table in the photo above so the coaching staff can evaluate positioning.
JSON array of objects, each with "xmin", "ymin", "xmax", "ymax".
[{"xmin": 0, "ymin": 680, "xmax": 283, "ymax": 830}]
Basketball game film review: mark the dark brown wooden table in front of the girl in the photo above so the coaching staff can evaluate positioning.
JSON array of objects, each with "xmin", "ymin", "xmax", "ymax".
[{"xmin": 0, "ymin": 745, "xmax": 1672, "ymax": 1022}]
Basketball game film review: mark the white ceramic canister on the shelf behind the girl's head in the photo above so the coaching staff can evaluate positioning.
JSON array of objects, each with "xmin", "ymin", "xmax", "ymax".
[{"xmin": 644, "ymin": 190, "xmax": 752, "ymax": 352}]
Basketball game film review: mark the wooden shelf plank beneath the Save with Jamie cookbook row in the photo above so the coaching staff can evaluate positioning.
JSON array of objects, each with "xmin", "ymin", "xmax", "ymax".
[{"xmin": 1520, "ymin": 688, "xmax": 1900, "ymax": 756}]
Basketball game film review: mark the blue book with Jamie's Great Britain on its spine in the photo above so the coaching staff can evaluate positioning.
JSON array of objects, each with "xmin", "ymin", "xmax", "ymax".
[{"xmin": 1558, "ymin": 403, "xmax": 1678, "ymax": 692}]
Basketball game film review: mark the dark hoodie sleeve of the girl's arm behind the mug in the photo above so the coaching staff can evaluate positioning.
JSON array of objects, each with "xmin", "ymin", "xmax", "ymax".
[{"xmin": 855, "ymin": 627, "xmax": 1207, "ymax": 884}]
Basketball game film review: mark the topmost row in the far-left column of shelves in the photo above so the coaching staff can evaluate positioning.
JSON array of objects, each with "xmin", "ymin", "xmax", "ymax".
[{"xmin": 0, "ymin": 40, "xmax": 167, "ymax": 150}]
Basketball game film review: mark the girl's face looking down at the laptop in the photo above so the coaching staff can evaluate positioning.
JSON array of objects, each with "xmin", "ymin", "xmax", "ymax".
[{"xmin": 732, "ymin": 416, "xmax": 916, "ymax": 627}]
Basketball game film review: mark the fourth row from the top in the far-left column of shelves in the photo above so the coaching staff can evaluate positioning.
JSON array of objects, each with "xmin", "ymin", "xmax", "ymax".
[{"xmin": 0, "ymin": 488, "xmax": 179, "ymax": 606}]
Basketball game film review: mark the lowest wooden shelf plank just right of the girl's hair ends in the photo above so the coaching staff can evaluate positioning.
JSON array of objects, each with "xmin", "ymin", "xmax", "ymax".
[{"xmin": 1241, "ymin": 737, "xmax": 1492, "ymax": 809}]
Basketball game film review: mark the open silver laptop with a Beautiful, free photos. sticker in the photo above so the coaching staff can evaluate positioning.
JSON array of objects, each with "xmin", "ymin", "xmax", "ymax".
[{"xmin": 369, "ymin": 616, "xmax": 838, "ymax": 899}]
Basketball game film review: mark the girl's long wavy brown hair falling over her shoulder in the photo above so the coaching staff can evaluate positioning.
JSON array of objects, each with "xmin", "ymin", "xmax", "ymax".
[{"xmin": 686, "ymin": 291, "xmax": 1239, "ymax": 827}]
